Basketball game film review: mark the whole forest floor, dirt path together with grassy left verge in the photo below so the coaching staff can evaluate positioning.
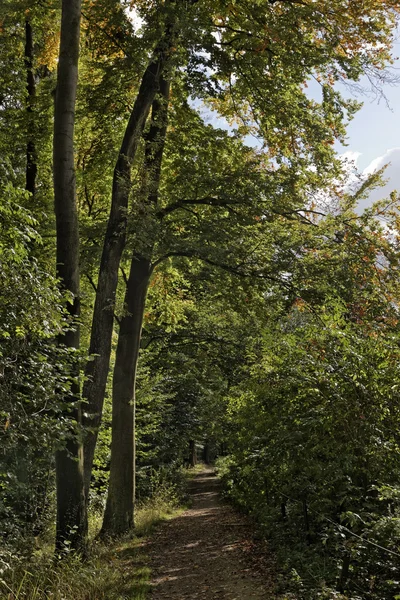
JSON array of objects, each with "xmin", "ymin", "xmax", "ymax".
[{"xmin": 0, "ymin": 468, "xmax": 296, "ymax": 600}]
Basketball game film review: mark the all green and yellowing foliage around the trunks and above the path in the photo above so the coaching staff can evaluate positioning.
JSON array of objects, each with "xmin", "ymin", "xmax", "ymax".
[{"xmin": 0, "ymin": 0, "xmax": 400, "ymax": 600}]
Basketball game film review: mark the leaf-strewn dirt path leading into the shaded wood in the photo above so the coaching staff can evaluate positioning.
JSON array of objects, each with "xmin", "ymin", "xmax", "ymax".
[{"xmin": 146, "ymin": 469, "xmax": 278, "ymax": 600}]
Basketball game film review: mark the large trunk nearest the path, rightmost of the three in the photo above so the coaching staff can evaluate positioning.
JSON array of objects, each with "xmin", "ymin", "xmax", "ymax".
[{"xmin": 103, "ymin": 77, "xmax": 170, "ymax": 535}]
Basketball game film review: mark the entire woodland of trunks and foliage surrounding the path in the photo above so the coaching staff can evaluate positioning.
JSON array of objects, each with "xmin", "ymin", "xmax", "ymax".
[{"xmin": 0, "ymin": 0, "xmax": 400, "ymax": 600}]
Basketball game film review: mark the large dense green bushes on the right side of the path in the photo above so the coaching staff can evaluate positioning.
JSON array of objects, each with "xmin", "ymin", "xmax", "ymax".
[{"xmin": 219, "ymin": 200, "xmax": 400, "ymax": 600}]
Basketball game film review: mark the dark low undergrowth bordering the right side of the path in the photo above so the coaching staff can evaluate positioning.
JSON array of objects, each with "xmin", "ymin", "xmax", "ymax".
[{"xmin": 217, "ymin": 457, "xmax": 400, "ymax": 600}]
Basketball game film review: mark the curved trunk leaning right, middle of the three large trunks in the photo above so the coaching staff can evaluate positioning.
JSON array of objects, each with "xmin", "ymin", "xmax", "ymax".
[{"xmin": 83, "ymin": 41, "xmax": 173, "ymax": 492}]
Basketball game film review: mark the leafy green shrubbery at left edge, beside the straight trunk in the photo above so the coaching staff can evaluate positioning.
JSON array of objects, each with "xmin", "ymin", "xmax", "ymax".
[{"xmin": 0, "ymin": 184, "xmax": 79, "ymax": 553}]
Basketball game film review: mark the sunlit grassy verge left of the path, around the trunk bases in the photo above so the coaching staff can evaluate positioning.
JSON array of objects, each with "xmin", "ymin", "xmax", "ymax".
[{"xmin": 0, "ymin": 485, "xmax": 184, "ymax": 600}]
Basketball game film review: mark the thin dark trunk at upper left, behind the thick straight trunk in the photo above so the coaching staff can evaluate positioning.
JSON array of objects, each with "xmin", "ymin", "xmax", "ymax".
[{"xmin": 25, "ymin": 19, "xmax": 37, "ymax": 196}]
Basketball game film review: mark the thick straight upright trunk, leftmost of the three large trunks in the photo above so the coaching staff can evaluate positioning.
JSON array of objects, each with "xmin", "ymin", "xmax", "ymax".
[{"xmin": 53, "ymin": 0, "xmax": 87, "ymax": 552}]
